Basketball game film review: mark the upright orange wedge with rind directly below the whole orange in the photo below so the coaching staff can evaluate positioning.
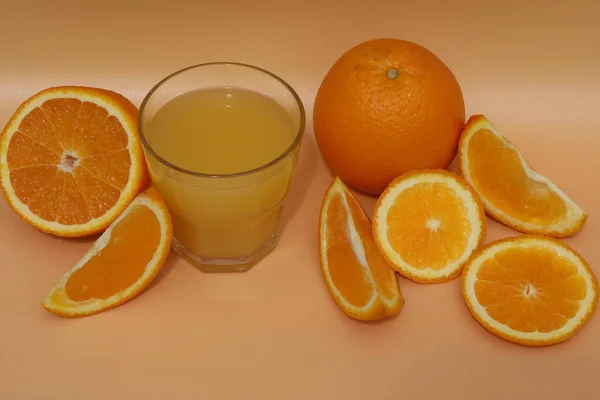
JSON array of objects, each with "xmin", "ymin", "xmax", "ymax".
[{"xmin": 319, "ymin": 177, "xmax": 404, "ymax": 321}]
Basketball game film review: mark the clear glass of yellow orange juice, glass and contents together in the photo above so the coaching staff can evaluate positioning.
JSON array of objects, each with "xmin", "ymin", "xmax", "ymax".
[{"xmin": 139, "ymin": 62, "xmax": 305, "ymax": 272}]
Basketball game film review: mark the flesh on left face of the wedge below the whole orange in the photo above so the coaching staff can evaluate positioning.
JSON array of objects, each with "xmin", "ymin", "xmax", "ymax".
[{"xmin": 326, "ymin": 192, "xmax": 374, "ymax": 307}]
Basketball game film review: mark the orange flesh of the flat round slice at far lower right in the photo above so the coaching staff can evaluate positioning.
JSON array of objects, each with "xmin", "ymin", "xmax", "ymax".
[{"xmin": 475, "ymin": 246, "xmax": 586, "ymax": 332}]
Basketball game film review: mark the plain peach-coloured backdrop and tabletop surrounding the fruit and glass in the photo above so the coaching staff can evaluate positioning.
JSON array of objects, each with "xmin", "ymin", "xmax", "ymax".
[{"xmin": 0, "ymin": 0, "xmax": 600, "ymax": 400}]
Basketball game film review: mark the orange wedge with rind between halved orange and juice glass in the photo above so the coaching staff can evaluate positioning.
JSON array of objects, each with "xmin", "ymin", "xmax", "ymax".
[{"xmin": 42, "ymin": 187, "xmax": 172, "ymax": 317}]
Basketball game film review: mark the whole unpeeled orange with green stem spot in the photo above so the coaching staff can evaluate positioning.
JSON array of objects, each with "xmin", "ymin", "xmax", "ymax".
[{"xmin": 313, "ymin": 39, "xmax": 465, "ymax": 194}]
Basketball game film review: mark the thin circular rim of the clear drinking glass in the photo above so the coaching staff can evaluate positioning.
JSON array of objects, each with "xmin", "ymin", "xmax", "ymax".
[{"xmin": 137, "ymin": 61, "xmax": 306, "ymax": 178}]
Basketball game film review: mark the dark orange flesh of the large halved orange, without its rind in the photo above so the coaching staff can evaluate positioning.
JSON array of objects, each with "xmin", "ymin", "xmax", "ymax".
[{"xmin": 7, "ymin": 99, "xmax": 131, "ymax": 225}]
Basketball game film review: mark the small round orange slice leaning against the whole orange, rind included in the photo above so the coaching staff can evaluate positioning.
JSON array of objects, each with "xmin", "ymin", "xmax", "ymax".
[{"xmin": 373, "ymin": 170, "xmax": 485, "ymax": 283}]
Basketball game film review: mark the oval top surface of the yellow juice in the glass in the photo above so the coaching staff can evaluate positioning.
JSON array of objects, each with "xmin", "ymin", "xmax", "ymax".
[{"xmin": 146, "ymin": 87, "xmax": 296, "ymax": 175}]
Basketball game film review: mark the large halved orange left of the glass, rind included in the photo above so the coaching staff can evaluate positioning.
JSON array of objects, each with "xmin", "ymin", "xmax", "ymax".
[{"xmin": 0, "ymin": 86, "xmax": 148, "ymax": 236}]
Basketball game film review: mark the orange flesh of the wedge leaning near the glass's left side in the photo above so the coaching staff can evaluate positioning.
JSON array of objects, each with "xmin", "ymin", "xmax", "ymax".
[{"xmin": 58, "ymin": 206, "xmax": 161, "ymax": 301}]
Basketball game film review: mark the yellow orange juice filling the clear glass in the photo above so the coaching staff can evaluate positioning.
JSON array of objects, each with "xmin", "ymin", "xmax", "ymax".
[{"xmin": 144, "ymin": 87, "xmax": 299, "ymax": 267}]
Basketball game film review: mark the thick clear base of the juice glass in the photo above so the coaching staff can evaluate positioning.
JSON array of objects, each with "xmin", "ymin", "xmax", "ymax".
[{"xmin": 171, "ymin": 233, "xmax": 279, "ymax": 272}]
